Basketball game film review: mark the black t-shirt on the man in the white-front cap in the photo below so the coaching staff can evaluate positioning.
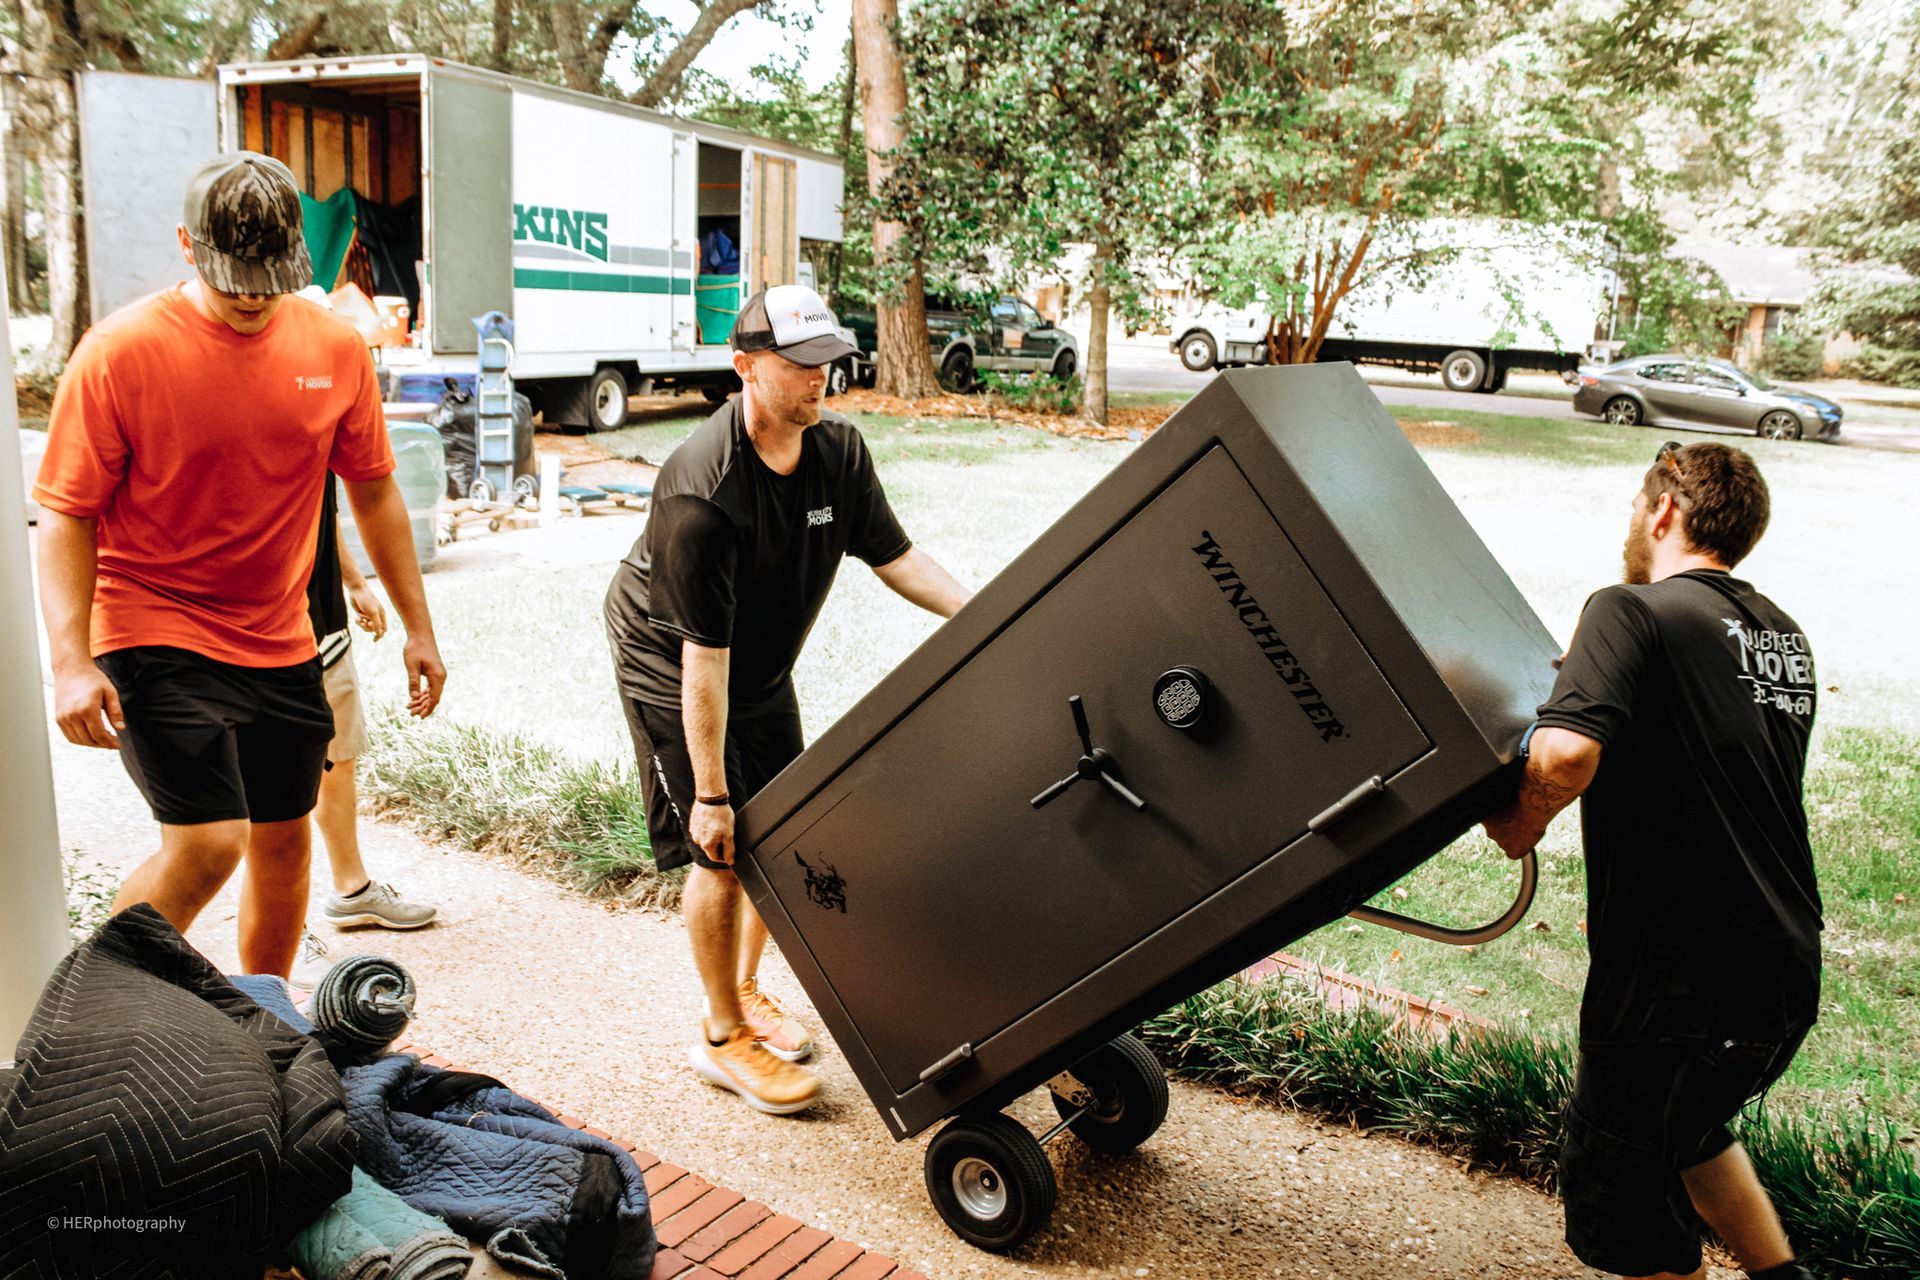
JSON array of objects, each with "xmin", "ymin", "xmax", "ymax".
[{"xmin": 607, "ymin": 395, "xmax": 912, "ymax": 720}]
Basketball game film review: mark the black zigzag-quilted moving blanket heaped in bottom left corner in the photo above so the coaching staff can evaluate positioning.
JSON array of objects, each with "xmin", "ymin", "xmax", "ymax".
[{"xmin": 0, "ymin": 904, "xmax": 355, "ymax": 1280}]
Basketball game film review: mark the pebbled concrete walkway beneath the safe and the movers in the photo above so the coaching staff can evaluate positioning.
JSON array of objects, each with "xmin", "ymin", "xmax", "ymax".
[{"xmin": 54, "ymin": 721, "xmax": 1666, "ymax": 1280}]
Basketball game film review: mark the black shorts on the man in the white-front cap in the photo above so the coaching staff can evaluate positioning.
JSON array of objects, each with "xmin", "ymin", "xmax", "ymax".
[{"xmin": 620, "ymin": 695, "xmax": 804, "ymax": 871}]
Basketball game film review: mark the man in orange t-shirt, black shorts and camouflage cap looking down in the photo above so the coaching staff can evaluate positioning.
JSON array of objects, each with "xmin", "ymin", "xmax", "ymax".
[{"xmin": 33, "ymin": 152, "xmax": 445, "ymax": 977}]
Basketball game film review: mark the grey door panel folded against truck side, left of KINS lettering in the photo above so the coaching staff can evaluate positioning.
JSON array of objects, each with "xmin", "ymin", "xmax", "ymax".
[{"xmin": 422, "ymin": 69, "xmax": 513, "ymax": 351}]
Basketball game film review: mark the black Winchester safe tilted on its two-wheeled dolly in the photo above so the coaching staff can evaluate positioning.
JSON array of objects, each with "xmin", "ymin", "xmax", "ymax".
[{"xmin": 739, "ymin": 365, "xmax": 1559, "ymax": 1249}]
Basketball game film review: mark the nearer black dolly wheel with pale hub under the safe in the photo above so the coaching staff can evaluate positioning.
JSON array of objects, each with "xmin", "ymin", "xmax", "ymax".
[{"xmin": 925, "ymin": 1115, "xmax": 1060, "ymax": 1253}]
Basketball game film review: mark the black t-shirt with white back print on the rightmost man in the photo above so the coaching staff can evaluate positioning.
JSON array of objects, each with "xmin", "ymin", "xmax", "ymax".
[{"xmin": 1540, "ymin": 570, "xmax": 1822, "ymax": 1044}]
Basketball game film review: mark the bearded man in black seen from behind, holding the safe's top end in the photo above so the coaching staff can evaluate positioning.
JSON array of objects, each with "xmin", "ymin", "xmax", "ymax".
[{"xmin": 1486, "ymin": 443, "xmax": 1822, "ymax": 1280}]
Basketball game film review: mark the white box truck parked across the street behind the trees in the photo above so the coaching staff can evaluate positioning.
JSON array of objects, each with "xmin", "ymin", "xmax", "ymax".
[{"xmin": 1169, "ymin": 223, "xmax": 1615, "ymax": 391}]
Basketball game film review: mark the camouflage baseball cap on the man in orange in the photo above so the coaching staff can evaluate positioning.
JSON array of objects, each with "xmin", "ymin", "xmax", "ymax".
[{"xmin": 182, "ymin": 152, "xmax": 313, "ymax": 294}]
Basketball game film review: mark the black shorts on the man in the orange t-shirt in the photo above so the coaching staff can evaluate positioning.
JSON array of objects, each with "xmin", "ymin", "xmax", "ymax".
[{"xmin": 94, "ymin": 645, "xmax": 334, "ymax": 825}]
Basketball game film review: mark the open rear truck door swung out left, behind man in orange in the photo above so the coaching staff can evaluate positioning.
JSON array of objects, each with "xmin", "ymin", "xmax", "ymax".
[{"xmin": 79, "ymin": 71, "xmax": 221, "ymax": 320}]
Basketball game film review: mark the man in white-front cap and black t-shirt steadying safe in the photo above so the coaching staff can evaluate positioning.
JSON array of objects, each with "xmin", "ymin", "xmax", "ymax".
[{"xmin": 607, "ymin": 284, "xmax": 968, "ymax": 1115}]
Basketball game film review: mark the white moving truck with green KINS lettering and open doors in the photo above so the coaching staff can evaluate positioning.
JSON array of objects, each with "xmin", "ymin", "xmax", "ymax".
[{"xmin": 81, "ymin": 54, "xmax": 843, "ymax": 430}]
